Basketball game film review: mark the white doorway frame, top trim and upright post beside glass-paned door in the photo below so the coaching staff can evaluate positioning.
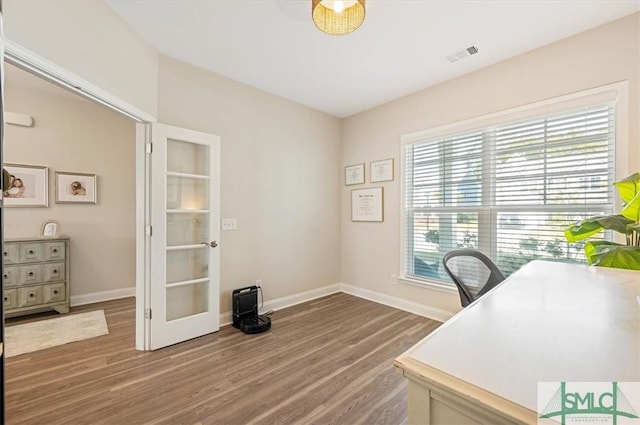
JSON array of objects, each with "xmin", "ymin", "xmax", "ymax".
[{"xmin": 3, "ymin": 38, "xmax": 157, "ymax": 351}]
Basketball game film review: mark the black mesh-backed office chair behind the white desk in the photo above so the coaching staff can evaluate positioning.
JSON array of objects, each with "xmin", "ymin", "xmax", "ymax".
[{"xmin": 442, "ymin": 249, "xmax": 504, "ymax": 307}]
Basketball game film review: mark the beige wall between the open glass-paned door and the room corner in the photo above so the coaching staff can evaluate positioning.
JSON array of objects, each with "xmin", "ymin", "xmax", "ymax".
[{"xmin": 158, "ymin": 56, "xmax": 341, "ymax": 312}]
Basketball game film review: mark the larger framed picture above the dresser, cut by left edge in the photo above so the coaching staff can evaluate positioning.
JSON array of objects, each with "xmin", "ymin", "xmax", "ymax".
[{"xmin": 2, "ymin": 164, "xmax": 49, "ymax": 207}]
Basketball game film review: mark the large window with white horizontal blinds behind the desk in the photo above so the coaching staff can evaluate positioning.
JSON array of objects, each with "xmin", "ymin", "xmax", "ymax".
[{"xmin": 403, "ymin": 102, "xmax": 615, "ymax": 282}]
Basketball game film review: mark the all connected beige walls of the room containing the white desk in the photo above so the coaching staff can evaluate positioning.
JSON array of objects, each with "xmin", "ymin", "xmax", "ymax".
[{"xmin": 3, "ymin": 0, "xmax": 640, "ymax": 318}]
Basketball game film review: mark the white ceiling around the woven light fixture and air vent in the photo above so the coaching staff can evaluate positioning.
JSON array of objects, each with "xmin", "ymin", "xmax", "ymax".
[{"xmin": 105, "ymin": 0, "xmax": 640, "ymax": 118}]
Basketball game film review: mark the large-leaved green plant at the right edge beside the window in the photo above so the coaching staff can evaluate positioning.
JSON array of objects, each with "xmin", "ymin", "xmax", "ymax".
[{"xmin": 564, "ymin": 173, "xmax": 640, "ymax": 270}]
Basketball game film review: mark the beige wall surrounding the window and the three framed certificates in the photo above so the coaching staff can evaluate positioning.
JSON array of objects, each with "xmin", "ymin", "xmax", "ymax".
[{"xmin": 341, "ymin": 14, "xmax": 640, "ymax": 311}]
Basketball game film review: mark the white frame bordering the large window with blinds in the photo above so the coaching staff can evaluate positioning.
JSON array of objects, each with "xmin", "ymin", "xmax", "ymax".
[{"xmin": 398, "ymin": 81, "xmax": 629, "ymax": 288}]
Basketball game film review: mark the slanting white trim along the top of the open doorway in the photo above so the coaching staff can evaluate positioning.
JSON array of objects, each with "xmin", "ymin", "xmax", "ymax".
[{"xmin": 4, "ymin": 39, "xmax": 157, "ymax": 122}]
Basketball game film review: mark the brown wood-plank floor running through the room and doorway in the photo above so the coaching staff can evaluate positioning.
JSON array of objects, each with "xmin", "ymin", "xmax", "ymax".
[{"xmin": 6, "ymin": 293, "xmax": 440, "ymax": 425}]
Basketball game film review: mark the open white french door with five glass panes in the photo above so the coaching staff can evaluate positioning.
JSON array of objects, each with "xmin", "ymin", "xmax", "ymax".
[{"xmin": 147, "ymin": 123, "xmax": 220, "ymax": 350}]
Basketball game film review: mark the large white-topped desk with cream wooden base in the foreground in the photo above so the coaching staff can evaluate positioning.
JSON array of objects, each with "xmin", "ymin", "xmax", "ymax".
[{"xmin": 394, "ymin": 261, "xmax": 640, "ymax": 425}]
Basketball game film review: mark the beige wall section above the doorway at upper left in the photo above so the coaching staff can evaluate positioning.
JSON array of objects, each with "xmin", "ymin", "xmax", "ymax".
[{"xmin": 2, "ymin": 0, "xmax": 158, "ymax": 116}]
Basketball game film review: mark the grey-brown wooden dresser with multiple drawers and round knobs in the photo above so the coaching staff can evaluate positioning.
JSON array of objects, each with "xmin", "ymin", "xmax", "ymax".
[{"xmin": 2, "ymin": 237, "xmax": 70, "ymax": 317}]
